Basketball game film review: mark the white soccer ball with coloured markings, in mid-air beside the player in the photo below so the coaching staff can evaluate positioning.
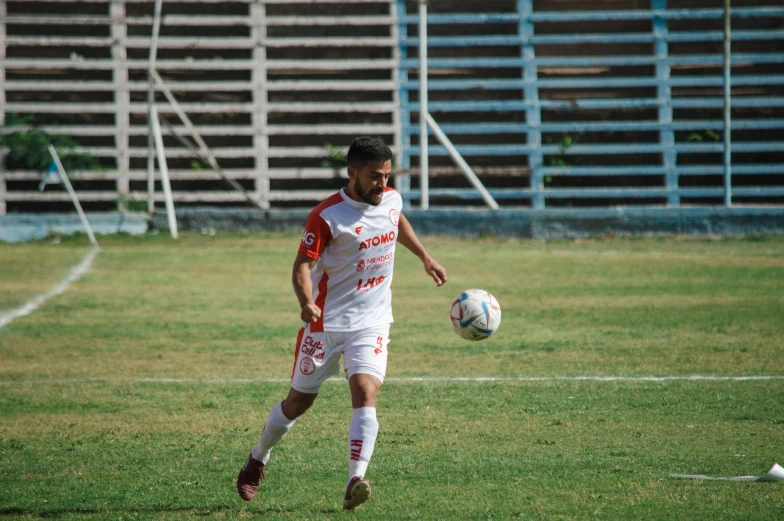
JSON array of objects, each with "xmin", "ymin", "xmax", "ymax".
[{"xmin": 449, "ymin": 289, "xmax": 501, "ymax": 340}]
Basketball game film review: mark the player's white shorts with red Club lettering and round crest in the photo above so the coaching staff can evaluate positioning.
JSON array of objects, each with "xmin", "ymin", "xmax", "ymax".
[{"xmin": 291, "ymin": 324, "xmax": 390, "ymax": 394}]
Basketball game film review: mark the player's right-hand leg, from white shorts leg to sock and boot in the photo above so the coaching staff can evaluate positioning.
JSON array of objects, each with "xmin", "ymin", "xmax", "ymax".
[{"xmin": 343, "ymin": 327, "xmax": 389, "ymax": 510}]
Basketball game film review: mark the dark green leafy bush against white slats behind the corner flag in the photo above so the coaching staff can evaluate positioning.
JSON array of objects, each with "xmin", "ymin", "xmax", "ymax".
[{"xmin": 0, "ymin": 113, "xmax": 100, "ymax": 172}]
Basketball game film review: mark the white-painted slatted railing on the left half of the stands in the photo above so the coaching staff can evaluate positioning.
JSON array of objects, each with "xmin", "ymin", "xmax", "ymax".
[{"xmin": 0, "ymin": 0, "xmax": 400, "ymax": 214}]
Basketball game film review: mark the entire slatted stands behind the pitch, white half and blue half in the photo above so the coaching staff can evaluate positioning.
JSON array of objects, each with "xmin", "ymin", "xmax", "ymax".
[{"xmin": 0, "ymin": 0, "xmax": 784, "ymax": 214}]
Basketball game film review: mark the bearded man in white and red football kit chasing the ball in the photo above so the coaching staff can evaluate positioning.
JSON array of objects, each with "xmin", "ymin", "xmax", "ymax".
[{"xmin": 237, "ymin": 137, "xmax": 446, "ymax": 510}]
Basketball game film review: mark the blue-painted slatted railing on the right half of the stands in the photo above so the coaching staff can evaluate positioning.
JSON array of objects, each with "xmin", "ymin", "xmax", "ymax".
[{"xmin": 397, "ymin": 0, "xmax": 784, "ymax": 208}]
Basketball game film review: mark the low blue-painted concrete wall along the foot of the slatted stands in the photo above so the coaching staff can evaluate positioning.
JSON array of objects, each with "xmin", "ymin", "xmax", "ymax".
[{"xmin": 0, "ymin": 208, "xmax": 784, "ymax": 242}]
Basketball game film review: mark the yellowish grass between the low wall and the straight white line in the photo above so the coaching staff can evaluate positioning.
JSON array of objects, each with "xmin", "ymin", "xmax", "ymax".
[{"xmin": 0, "ymin": 234, "xmax": 784, "ymax": 380}]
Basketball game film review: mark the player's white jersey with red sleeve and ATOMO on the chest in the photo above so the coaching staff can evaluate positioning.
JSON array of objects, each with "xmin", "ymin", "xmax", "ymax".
[{"xmin": 299, "ymin": 188, "xmax": 403, "ymax": 331}]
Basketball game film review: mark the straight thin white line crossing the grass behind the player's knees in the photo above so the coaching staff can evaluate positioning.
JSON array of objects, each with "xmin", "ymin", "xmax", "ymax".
[{"xmin": 0, "ymin": 375, "xmax": 784, "ymax": 385}]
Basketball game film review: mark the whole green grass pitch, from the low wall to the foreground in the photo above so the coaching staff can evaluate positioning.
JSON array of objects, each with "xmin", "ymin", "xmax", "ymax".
[{"xmin": 0, "ymin": 234, "xmax": 784, "ymax": 520}]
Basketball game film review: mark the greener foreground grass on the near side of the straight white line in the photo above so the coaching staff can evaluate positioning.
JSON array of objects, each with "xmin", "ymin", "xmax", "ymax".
[{"xmin": 0, "ymin": 382, "xmax": 784, "ymax": 519}]
